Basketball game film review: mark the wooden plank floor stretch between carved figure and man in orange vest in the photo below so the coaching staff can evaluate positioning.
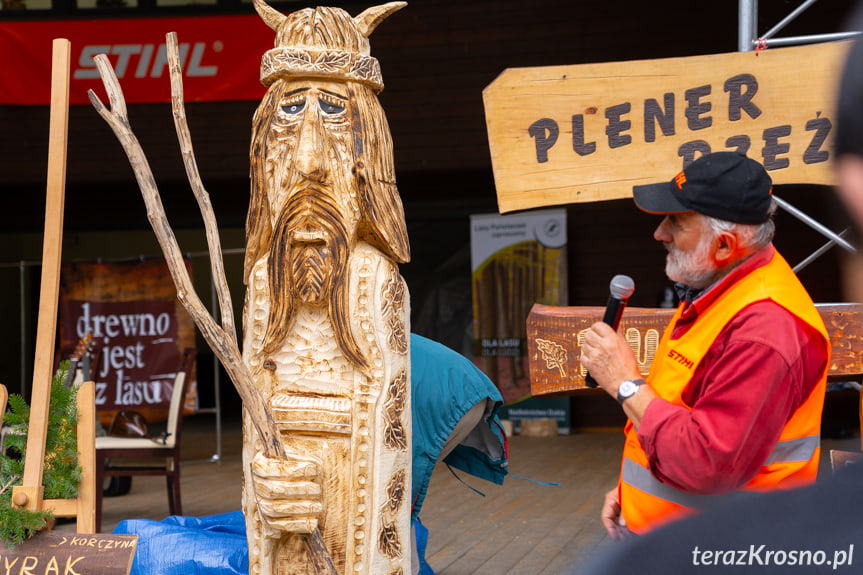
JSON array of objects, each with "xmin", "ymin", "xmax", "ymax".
[{"xmin": 420, "ymin": 432, "xmax": 623, "ymax": 575}]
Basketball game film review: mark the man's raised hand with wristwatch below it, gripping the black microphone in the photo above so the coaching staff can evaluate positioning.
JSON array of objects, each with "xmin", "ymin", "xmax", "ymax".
[{"xmin": 581, "ymin": 322, "xmax": 641, "ymax": 397}]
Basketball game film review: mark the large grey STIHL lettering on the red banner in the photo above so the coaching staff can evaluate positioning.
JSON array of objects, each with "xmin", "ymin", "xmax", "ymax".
[{"xmin": 72, "ymin": 40, "xmax": 223, "ymax": 80}]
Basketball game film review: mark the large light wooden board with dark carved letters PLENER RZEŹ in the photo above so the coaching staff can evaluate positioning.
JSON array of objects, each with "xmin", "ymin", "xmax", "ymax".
[{"xmin": 483, "ymin": 42, "xmax": 850, "ymax": 212}]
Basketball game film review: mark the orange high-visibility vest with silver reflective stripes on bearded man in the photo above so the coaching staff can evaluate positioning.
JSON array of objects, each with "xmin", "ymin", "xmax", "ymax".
[{"xmin": 618, "ymin": 251, "xmax": 830, "ymax": 533}]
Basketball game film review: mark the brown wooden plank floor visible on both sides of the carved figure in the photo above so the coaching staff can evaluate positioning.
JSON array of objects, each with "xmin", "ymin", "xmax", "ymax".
[{"xmin": 58, "ymin": 415, "xmax": 860, "ymax": 575}]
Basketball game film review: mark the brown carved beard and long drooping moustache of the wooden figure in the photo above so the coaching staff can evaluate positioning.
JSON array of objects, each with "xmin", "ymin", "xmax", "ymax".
[{"xmin": 263, "ymin": 187, "xmax": 368, "ymax": 369}]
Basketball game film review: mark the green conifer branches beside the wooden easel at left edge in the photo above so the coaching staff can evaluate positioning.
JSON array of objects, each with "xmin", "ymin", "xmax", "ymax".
[{"xmin": 0, "ymin": 361, "xmax": 81, "ymax": 549}]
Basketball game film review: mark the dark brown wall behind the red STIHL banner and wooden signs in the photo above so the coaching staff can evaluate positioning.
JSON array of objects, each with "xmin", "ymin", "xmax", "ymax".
[{"xmin": 0, "ymin": 0, "xmax": 854, "ymax": 420}]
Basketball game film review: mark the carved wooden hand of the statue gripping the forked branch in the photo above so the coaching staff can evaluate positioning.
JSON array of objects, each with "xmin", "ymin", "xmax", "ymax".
[{"xmin": 252, "ymin": 453, "xmax": 323, "ymax": 533}]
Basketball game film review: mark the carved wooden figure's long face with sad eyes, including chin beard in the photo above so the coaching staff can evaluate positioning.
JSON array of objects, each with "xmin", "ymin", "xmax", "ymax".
[{"xmin": 266, "ymin": 80, "xmax": 360, "ymax": 310}]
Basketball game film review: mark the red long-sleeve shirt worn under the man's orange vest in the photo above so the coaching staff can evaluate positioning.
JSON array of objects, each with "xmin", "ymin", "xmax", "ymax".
[{"xmin": 638, "ymin": 245, "xmax": 828, "ymax": 494}]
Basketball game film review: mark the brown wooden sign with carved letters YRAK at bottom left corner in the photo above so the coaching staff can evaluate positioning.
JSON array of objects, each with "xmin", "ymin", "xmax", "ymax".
[{"xmin": 0, "ymin": 531, "xmax": 138, "ymax": 575}]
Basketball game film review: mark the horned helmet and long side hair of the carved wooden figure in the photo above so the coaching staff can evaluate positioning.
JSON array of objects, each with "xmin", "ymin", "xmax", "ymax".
[{"xmin": 245, "ymin": 0, "xmax": 410, "ymax": 284}]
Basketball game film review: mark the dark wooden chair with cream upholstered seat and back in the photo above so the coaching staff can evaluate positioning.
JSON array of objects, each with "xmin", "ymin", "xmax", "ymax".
[{"xmin": 96, "ymin": 348, "xmax": 197, "ymax": 532}]
